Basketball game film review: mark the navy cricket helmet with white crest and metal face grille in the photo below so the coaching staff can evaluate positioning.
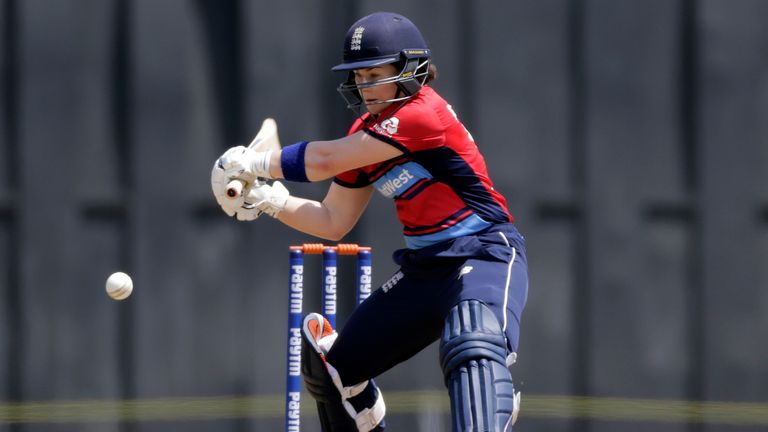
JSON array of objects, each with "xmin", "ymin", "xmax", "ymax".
[{"xmin": 331, "ymin": 12, "xmax": 430, "ymax": 116}]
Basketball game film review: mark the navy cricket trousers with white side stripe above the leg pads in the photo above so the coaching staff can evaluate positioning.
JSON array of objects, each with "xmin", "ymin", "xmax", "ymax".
[{"xmin": 326, "ymin": 224, "xmax": 528, "ymax": 386}]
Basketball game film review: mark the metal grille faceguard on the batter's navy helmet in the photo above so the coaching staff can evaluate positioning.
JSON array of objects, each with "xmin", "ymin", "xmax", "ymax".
[{"xmin": 337, "ymin": 57, "xmax": 429, "ymax": 117}]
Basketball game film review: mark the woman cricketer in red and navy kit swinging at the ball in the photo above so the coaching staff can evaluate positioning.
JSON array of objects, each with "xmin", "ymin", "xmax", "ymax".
[{"xmin": 211, "ymin": 12, "xmax": 528, "ymax": 431}]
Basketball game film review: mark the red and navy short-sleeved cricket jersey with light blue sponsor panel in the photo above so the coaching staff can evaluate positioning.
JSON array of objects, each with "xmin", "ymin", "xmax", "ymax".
[{"xmin": 334, "ymin": 86, "xmax": 513, "ymax": 249}]
